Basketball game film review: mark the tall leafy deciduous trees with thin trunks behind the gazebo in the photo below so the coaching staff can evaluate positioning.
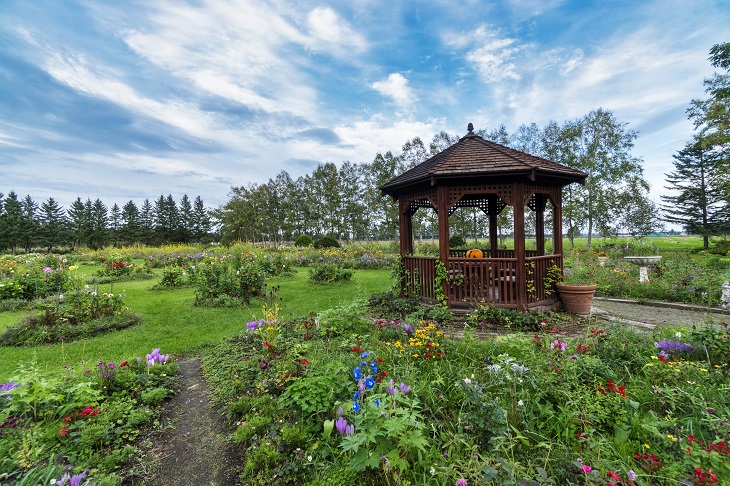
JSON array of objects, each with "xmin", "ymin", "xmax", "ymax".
[{"xmin": 214, "ymin": 108, "xmax": 661, "ymax": 249}]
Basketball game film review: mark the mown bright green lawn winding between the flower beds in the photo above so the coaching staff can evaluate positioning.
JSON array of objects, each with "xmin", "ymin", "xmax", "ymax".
[{"xmin": 0, "ymin": 269, "xmax": 391, "ymax": 383}]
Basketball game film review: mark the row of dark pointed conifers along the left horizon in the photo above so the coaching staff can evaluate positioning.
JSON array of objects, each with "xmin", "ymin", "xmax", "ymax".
[{"xmin": 0, "ymin": 194, "xmax": 217, "ymax": 254}]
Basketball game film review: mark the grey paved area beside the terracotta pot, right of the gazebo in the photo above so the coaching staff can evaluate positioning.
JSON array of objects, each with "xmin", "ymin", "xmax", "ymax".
[{"xmin": 591, "ymin": 297, "xmax": 730, "ymax": 327}]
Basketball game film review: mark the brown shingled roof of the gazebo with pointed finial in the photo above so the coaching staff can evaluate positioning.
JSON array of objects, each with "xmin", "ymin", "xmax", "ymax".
[{"xmin": 380, "ymin": 123, "xmax": 588, "ymax": 196}]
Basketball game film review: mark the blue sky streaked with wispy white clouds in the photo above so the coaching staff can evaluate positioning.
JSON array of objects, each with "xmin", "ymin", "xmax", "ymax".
[{"xmin": 0, "ymin": 0, "xmax": 730, "ymax": 211}]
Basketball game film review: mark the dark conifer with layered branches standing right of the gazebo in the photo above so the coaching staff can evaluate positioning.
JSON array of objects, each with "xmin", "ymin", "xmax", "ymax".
[{"xmin": 661, "ymin": 140, "xmax": 727, "ymax": 248}]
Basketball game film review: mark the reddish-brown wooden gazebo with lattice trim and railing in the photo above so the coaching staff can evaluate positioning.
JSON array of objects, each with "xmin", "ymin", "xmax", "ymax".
[{"xmin": 380, "ymin": 123, "xmax": 587, "ymax": 310}]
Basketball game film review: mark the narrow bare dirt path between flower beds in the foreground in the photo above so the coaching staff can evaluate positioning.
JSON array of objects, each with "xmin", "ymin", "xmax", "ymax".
[{"xmin": 143, "ymin": 358, "xmax": 242, "ymax": 486}]
